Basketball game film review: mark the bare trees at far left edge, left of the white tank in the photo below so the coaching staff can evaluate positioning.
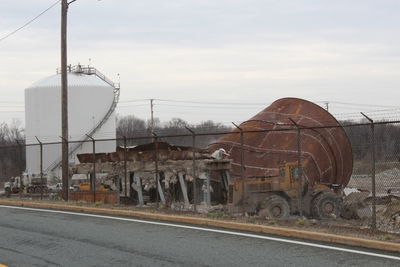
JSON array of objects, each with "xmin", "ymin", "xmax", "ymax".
[{"xmin": 0, "ymin": 120, "xmax": 25, "ymax": 181}]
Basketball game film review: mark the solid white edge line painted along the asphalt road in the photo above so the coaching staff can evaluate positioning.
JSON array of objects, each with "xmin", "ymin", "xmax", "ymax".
[{"xmin": 0, "ymin": 205, "xmax": 400, "ymax": 261}]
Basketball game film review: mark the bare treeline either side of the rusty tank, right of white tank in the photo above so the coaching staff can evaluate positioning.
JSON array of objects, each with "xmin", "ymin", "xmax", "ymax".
[{"xmin": 117, "ymin": 115, "xmax": 400, "ymax": 163}]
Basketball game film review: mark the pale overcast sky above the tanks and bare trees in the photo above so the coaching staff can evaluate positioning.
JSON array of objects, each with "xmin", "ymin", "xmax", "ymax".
[{"xmin": 0, "ymin": 0, "xmax": 400, "ymax": 126}]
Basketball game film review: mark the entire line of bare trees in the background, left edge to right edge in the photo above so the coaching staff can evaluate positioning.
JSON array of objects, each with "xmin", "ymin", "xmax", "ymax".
[{"xmin": 0, "ymin": 115, "xmax": 400, "ymax": 182}]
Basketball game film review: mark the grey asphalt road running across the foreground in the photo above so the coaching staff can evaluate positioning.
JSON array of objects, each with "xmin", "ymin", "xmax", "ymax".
[{"xmin": 0, "ymin": 206, "xmax": 400, "ymax": 267}]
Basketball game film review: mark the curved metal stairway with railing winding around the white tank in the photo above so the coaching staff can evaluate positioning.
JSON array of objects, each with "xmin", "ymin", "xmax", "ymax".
[{"xmin": 45, "ymin": 65, "xmax": 120, "ymax": 172}]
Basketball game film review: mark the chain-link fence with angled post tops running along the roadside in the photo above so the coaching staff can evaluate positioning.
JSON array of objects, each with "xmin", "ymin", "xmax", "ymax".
[{"xmin": 0, "ymin": 121, "xmax": 400, "ymax": 231}]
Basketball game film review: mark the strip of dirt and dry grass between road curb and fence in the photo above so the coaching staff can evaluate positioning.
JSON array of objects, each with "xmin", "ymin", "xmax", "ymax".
[{"xmin": 3, "ymin": 196, "xmax": 400, "ymax": 246}]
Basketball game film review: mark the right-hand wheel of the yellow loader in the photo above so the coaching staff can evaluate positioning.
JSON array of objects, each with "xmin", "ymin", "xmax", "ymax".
[{"xmin": 311, "ymin": 192, "xmax": 342, "ymax": 219}]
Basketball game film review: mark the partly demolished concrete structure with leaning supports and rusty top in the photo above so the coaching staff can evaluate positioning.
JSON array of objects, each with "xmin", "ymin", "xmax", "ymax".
[{"xmin": 73, "ymin": 142, "xmax": 230, "ymax": 207}]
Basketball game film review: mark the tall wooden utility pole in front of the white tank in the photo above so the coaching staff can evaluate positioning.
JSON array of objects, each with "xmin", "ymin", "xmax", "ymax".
[{"xmin": 61, "ymin": 0, "xmax": 69, "ymax": 201}]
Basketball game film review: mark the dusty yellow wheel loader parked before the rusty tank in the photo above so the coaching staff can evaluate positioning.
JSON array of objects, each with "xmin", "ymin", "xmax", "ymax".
[{"xmin": 228, "ymin": 162, "xmax": 342, "ymax": 219}]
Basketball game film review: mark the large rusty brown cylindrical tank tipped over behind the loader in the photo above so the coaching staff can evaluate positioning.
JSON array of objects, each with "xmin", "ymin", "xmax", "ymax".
[{"xmin": 209, "ymin": 98, "xmax": 353, "ymax": 186}]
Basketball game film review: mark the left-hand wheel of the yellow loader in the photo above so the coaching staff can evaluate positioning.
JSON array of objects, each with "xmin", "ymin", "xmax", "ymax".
[{"xmin": 258, "ymin": 195, "xmax": 290, "ymax": 219}]
